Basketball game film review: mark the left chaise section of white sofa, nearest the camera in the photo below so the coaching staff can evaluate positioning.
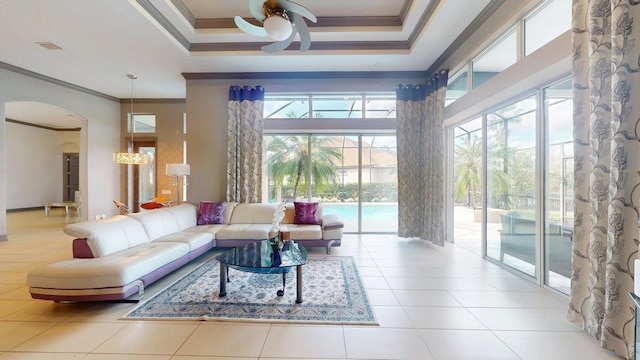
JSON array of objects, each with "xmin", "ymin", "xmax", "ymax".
[{"xmin": 27, "ymin": 204, "xmax": 213, "ymax": 301}]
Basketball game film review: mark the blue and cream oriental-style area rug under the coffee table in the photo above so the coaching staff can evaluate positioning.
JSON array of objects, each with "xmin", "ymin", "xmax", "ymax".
[{"xmin": 124, "ymin": 256, "xmax": 377, "ymax": 325}]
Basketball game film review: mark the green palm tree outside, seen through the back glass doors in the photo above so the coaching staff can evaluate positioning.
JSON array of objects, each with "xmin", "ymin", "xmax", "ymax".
[{"xmin": 267, "ymin": 135, "xmax": 342, "ymax": 199}]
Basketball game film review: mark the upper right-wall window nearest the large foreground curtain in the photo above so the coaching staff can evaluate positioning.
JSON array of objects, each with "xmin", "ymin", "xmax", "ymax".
[{"xmin": 524, "ymin": 0, "xmax": 571, "ymax": 56}]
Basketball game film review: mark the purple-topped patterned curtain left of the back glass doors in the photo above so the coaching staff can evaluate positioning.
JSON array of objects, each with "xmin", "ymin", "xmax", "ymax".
[{"xmin": 227, "ymin": 86, "xmax": 264, "ymax": 202}]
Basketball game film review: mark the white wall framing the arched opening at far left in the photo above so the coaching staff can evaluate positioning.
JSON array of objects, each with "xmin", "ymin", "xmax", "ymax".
[{"xmin": 0, "ymin": 68, "xmax": 121, "ymax": 240}]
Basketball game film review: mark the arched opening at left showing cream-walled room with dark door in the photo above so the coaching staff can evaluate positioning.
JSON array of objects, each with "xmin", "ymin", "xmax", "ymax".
[{"xmin": 3, "ymin": 101, "xmax": 87, "ymax": 235}]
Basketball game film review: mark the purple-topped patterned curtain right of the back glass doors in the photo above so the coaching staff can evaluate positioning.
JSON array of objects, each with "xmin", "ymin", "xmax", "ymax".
[{"xmin": 396, "ymin": 70, "xmax": 449, "ymax": 246}]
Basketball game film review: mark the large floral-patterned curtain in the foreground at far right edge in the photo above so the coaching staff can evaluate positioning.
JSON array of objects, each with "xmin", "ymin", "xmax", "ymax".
[{"xmin": 568, "ymin": 0, "xmax": 640, "ymax": 359}]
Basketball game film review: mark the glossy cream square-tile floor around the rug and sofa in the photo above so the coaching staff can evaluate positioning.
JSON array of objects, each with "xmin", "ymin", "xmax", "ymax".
[{"xmin": 0, "ymin": 210, "xmax": 619, "ymax": 360}]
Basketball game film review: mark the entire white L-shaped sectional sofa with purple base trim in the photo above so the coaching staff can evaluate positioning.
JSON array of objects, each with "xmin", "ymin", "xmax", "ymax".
[{"xmin": 27, "ymin": 203, "xmax": 343, "ymax": 302}]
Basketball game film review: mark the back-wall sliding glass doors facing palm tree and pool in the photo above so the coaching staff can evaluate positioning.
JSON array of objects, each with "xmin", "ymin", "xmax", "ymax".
[{"xmin": 264, "ymin": 134, "xmax": 398, "ymax": 233}]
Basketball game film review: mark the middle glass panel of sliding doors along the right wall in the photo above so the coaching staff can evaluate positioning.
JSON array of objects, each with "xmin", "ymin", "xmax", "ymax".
[{"xmin": 486, "ymin": 96, "xmax": 538, "ymax": 276}]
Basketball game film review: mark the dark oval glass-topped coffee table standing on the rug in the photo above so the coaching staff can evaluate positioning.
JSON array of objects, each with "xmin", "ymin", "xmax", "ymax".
[{"xmin": 216, "ymin": 240, "xmax": 307, "ymax": 304}]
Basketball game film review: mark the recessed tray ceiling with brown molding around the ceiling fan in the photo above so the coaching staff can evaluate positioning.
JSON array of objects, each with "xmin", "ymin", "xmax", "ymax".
[{"xmin": 136, "ymin": 0, "xmax": 442, "ymax": 54}]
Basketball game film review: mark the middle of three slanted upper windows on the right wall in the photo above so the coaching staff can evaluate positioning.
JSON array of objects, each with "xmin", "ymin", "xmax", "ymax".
[{"xmin": 472, "ymin": 28, "xmax": 518, "ymax": 89}]
